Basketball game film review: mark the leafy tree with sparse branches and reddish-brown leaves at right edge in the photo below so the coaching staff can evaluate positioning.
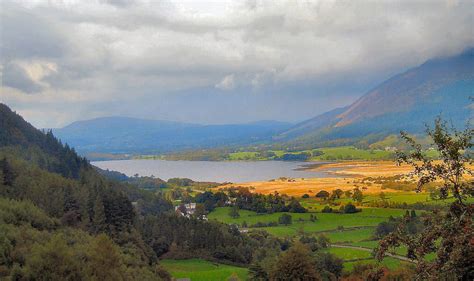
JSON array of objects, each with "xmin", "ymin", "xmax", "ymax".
[{"xmin": 377, "ymin": 118, "xmax": 474, "ymax": 280}]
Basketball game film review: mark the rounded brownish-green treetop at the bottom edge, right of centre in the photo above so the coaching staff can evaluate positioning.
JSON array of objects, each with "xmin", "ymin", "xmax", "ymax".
[{"xmin": 270, "ymin": 242, "xmax": 321, "ymax": 281}]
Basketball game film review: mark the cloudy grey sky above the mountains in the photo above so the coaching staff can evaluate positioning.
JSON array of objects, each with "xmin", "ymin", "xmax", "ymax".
[{"xmin": 0, "ymin": 0, "xmax": 474, "ymax": 128}]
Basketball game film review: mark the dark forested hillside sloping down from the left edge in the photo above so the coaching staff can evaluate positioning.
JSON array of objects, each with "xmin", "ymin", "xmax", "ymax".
[{"xmin": 0, "ymin": 104, "xmax": 300, "ymax": 280}]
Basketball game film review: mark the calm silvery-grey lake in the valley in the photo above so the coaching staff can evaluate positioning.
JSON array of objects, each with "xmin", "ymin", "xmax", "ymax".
[{"xmin": 92, "ymin": 160, "xmax": 329, "ymax": 183}]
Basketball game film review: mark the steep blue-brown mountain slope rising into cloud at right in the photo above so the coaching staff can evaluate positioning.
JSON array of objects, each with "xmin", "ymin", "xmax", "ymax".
[{"xmin": 275, "ymin": 49, "xmax": 474, "ymax": 146}]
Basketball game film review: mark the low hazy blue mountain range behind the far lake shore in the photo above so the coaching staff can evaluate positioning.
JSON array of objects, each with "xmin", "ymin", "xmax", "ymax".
[{"xmin": 53, "ymin": 117, "xmax": 291, "ymax": 154}]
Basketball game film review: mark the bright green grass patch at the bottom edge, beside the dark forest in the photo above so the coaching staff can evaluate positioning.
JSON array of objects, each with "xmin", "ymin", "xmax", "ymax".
[{"xmin": 160, "ymin": 259, "xmax": 248, "ymax": 281}]
